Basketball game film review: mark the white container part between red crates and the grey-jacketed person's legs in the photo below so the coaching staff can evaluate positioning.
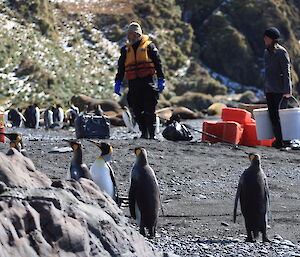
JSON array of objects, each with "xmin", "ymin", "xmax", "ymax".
[{"xmin": 253, "ymin": 108, "xmax": 274, "ymax": 140}]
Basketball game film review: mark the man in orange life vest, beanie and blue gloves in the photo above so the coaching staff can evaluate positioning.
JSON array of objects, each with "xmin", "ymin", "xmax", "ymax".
[{"xmin": 115, "ymin": 22, "xmax": 165, "ymax": 139}]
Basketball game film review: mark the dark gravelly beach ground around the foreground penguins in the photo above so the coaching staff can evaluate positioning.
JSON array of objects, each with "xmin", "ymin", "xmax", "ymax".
[{"xmin": 0, "ymin": 121, "xmax": 300, "ymax": 256}]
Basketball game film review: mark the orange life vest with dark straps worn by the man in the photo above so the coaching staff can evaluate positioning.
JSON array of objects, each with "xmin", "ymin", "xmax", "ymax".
[{"xmin": 125, "ymin": 35, "xmax": 156, "ymax": 80}]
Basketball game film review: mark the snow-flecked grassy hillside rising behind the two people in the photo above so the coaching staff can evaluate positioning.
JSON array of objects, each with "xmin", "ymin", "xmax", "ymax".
[{"xmin": 0, "ymin": 0, "xmax": 300, "ymax": 107}]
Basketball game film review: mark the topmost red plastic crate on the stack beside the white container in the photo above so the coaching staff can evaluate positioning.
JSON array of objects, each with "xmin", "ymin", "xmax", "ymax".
[{"xmin": 221, "ymin": 107, "xmax": 253, "ymax": 124}]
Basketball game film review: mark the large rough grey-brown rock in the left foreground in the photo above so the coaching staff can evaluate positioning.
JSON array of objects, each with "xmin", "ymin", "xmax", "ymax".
[{"xmin": 0, "ymin": 151, "xmax": 173, "ymax": 257}]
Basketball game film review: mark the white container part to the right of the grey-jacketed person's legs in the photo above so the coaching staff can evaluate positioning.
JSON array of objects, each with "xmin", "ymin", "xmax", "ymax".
[{"xmin": 279, "ymin": 107, "xmax": 300, "ymax": 140}]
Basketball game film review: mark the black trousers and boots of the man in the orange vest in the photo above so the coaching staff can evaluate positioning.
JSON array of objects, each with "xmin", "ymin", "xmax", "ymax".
[{"xmin": 127, "ymin": 76, "xmax": 158, "ymax": 138}]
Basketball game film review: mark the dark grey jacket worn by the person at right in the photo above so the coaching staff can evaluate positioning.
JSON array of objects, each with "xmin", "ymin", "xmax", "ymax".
[{"xmin": 264, "ymin": 44, "xmax": 292, "ymax": 94}]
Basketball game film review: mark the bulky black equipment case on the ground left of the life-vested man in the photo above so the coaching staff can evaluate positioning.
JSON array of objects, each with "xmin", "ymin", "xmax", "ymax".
[{"xmin": 75, "ymin": 114, "xmax": 110, "ymax": 139}]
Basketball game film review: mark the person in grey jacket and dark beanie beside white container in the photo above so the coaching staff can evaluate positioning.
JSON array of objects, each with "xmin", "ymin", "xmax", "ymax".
[{"xmin": 264, "ymin": 27, "xmax": 292, "ymax": 148}]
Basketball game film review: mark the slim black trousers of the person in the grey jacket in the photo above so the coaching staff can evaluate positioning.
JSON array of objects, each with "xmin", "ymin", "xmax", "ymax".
[{"xmin": 266, "ymin": 93, "xmax": 287, "ymax": 146}]
